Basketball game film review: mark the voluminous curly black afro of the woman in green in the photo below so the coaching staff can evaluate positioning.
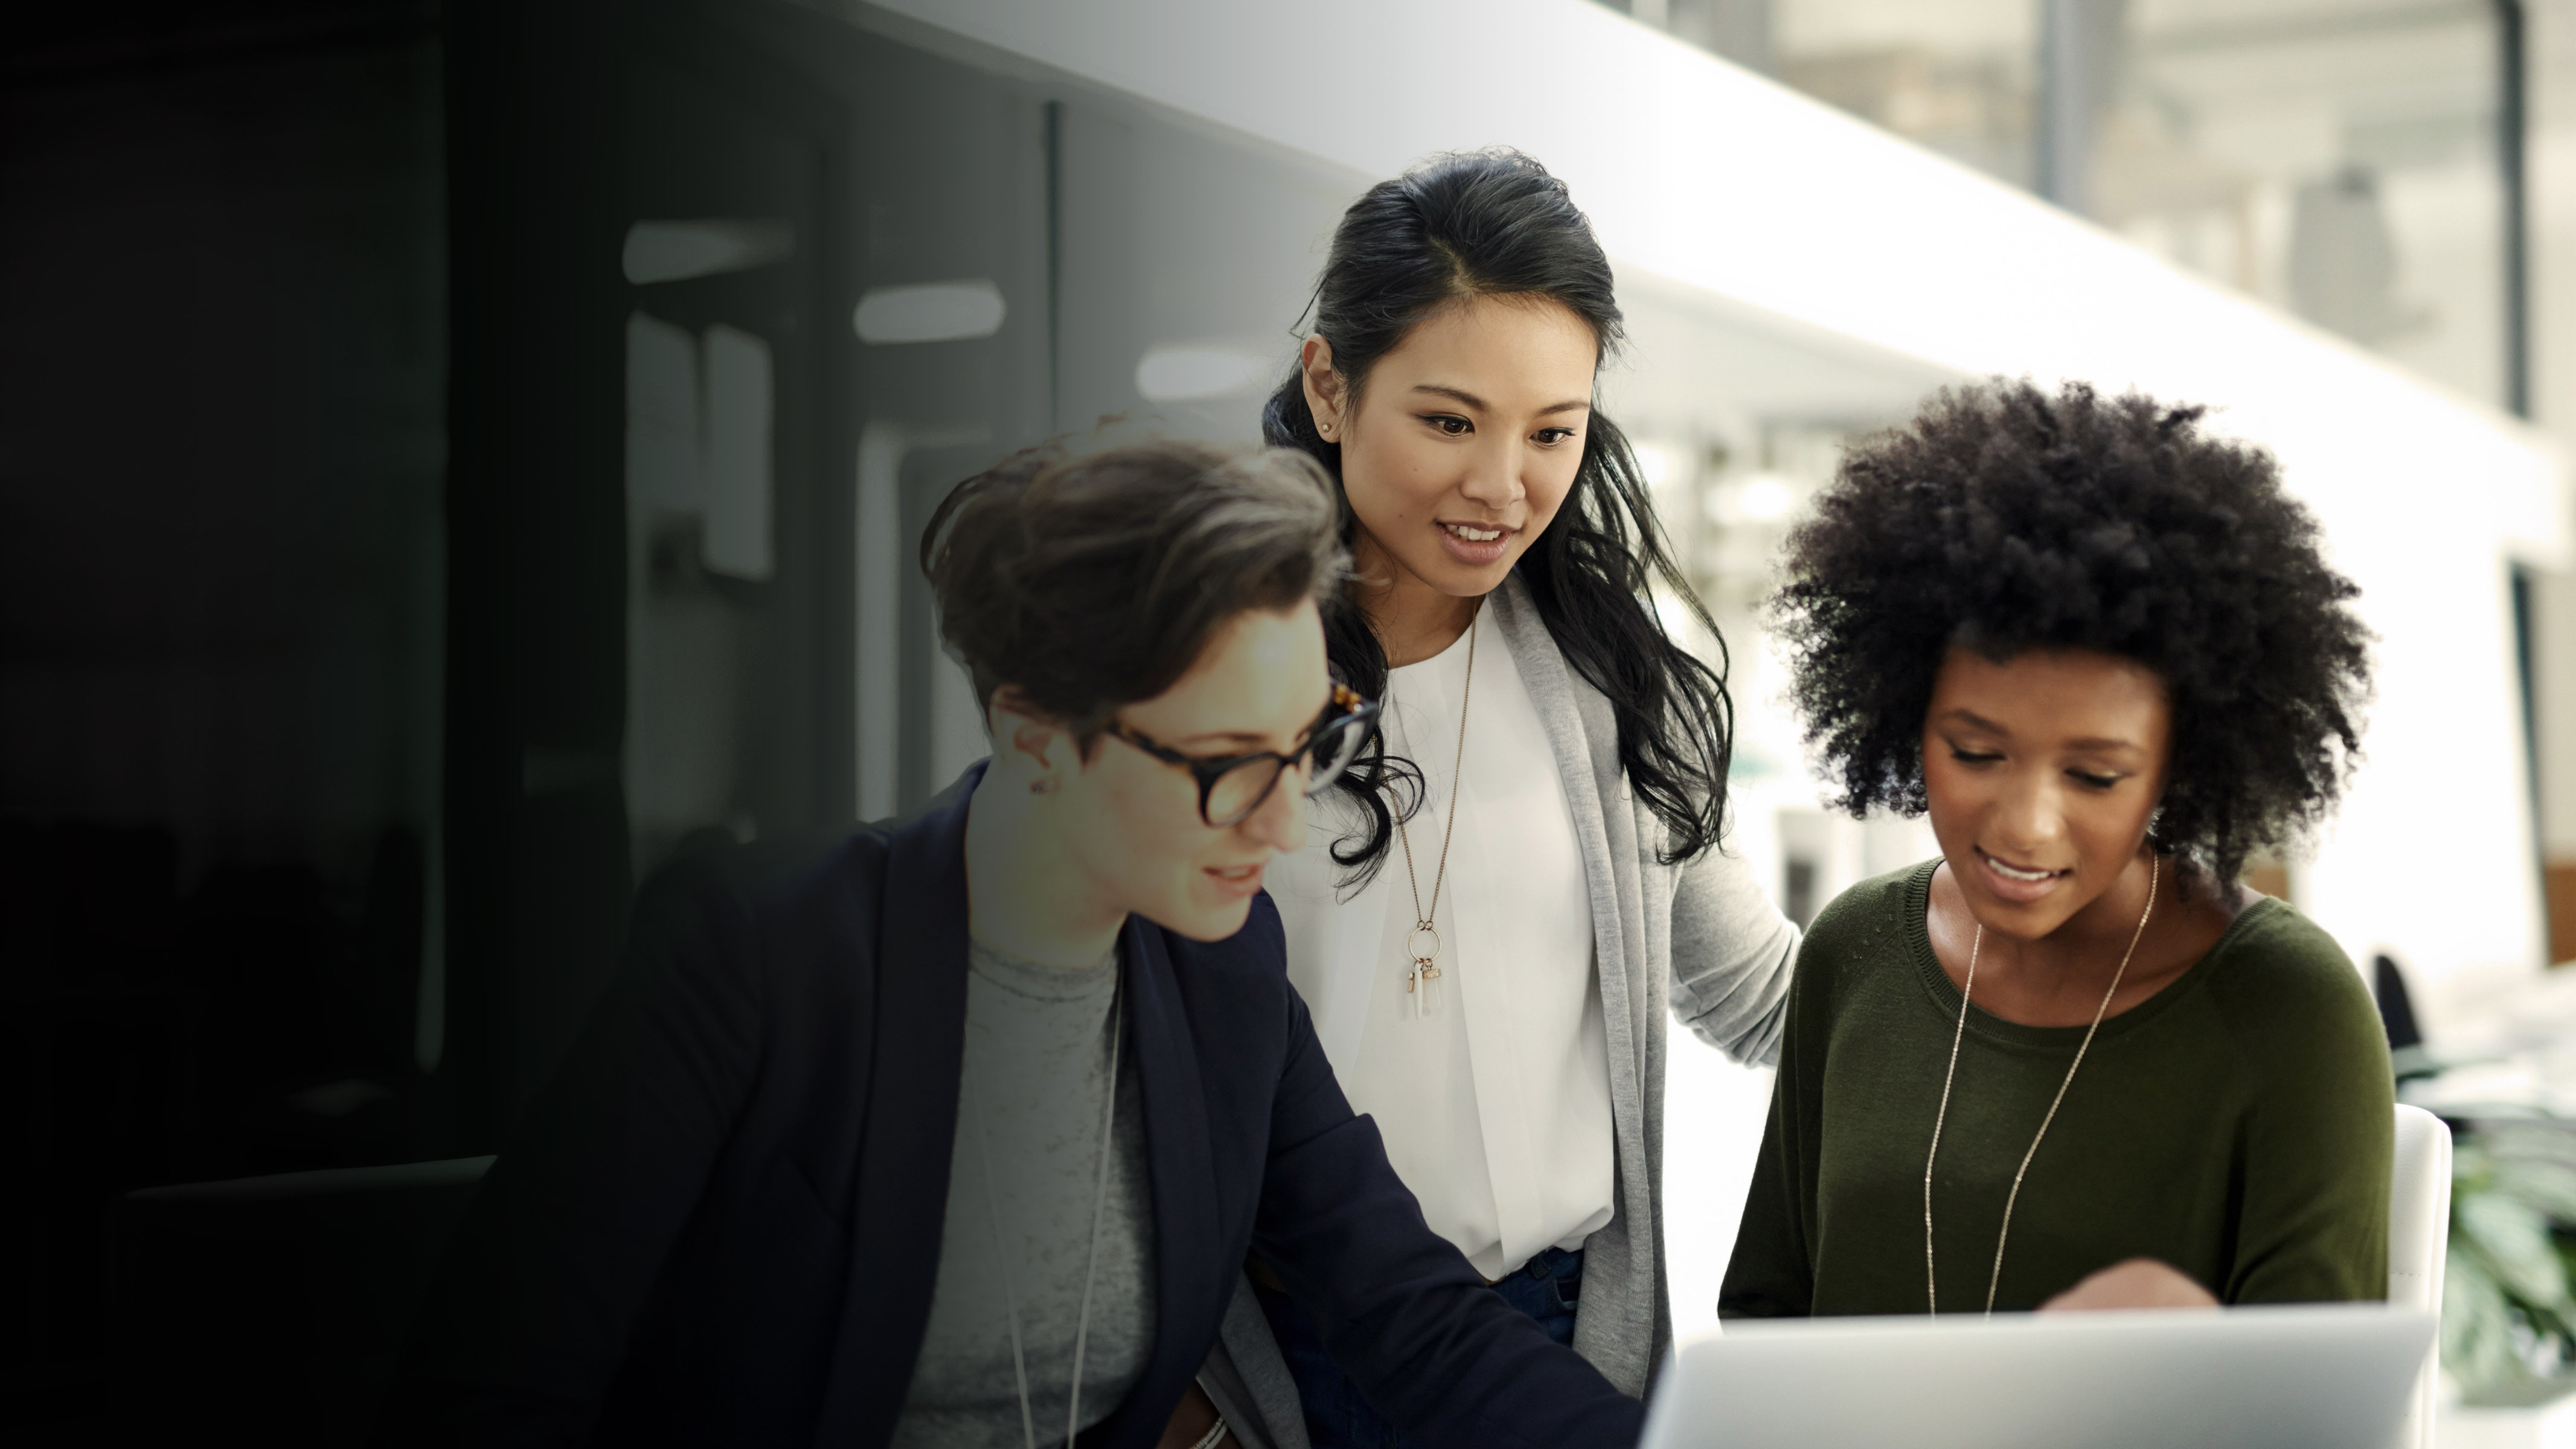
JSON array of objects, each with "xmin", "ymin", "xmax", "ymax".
[{"xmin": 1770, "ymin": 381, "xmax": 2370, "ymax": 880}]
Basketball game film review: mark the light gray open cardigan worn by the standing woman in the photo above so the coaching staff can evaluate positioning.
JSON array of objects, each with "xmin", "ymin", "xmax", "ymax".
[{"xmin": 1203, "ymin": 571, "xmax": 1798, "ymax": 1449}]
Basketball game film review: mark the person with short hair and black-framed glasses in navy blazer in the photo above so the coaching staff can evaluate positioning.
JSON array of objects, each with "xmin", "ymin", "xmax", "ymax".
[{"xmin": 389, "ymin": 443, "xmax": 1638, "ymax": 1449}]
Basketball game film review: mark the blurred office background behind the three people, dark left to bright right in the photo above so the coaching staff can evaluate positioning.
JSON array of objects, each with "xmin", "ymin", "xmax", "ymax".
[{"xmin": 15, "ymin": 0, "xmax": 2576, "ymax": 1444}]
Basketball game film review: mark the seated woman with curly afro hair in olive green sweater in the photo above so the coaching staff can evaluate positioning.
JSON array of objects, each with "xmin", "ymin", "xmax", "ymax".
[{"xmin": 1718, "ymin": 383, "xmax": 2391, "ymax": 1318}]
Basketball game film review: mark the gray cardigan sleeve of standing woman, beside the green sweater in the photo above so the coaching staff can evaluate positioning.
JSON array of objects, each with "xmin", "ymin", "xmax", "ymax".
[{"xmin": 1641, "ymin": 821, "xmax": 1798, "ymax": 1066}]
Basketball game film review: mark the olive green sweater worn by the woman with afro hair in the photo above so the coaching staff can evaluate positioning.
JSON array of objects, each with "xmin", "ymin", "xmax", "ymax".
[{"xmin": 1718, "ymin": 862, "xmax": 2393, "ymax": 1318}]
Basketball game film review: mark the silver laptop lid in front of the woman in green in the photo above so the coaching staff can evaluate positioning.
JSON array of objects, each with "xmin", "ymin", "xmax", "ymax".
[{"xmin": 1644, "ymin": 1305, "xmax": 2434, "ymax": 1449}]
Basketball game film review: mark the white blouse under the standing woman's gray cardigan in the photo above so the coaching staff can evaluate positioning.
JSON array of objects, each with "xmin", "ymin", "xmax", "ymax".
[{"xmin": 1267, "ymin": 610, "xmax": 1615, "ymax": 1279}]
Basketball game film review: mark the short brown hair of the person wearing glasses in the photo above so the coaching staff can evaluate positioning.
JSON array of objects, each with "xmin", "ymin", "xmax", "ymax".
[{"xmin": 922, "ymin": 438, "xmax": 1347, "ymax": 752}]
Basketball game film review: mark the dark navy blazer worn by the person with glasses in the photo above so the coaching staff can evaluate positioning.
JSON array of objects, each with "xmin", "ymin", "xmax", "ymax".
[{"xmin": 386, "ymin": 767, "xmax": 1644, "ymax": 1449}]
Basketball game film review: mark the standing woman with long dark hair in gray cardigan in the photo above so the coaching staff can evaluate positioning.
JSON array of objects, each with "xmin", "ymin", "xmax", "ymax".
[{"xmin": 1226, "ymin": 149, "xmax": 1798, "ymax": 1447}]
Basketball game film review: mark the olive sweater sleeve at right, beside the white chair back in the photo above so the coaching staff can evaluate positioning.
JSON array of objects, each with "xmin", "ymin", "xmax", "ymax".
[{"xmin": 2212, "ymin": 909, "xmax": 2395, "ymax": 1302}]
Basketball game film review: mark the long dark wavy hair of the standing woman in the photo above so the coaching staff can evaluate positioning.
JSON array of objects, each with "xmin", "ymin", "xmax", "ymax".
[{"xmin": 1262, "ymin": 149, "xmax": 1734, "ymax": 883}]
